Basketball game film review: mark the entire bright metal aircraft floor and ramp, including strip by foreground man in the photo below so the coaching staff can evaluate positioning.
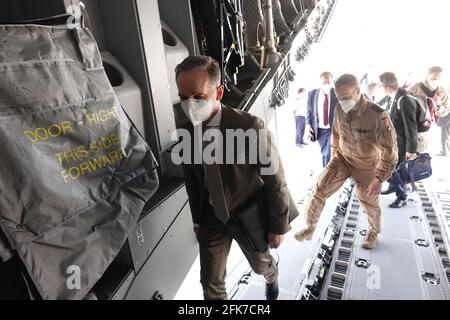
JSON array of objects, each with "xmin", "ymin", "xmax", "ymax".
[{"xmin": 230, "ymin": 183, "xmax": 450, "ymax": 300}]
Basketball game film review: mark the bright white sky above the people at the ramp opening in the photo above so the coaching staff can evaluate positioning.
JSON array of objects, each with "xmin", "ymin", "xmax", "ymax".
[{"xmin": 297, "ymin": 0, "xmax": 450, "ymax": 88}]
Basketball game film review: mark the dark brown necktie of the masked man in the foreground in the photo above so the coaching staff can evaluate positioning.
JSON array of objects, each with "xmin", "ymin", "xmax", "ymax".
[{"xmin": 205, "ymin": 141, "xmax": 230, "ymax": 224}]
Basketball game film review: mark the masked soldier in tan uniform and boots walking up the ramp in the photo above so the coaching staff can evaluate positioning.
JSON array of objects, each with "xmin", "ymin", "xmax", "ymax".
[{"xmin": 295, "ymin": 74, "xmax": 398, "ymax": 249}]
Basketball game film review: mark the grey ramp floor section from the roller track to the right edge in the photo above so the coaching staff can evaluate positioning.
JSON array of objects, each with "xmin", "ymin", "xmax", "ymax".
[{"xmin": 321, "ymin": 182, "xmax": 450, "ymax": 300}]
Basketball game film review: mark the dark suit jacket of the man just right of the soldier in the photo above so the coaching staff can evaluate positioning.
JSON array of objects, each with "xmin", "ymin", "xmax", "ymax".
[{"xmin": 390, "ymin": 88, "xmax": 417, "ymax": 162}]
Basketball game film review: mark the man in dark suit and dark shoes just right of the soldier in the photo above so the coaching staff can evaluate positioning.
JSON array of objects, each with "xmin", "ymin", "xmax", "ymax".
[{"xmin": 380, "ymin": 72, "xmax": 417, "ymax": 208}]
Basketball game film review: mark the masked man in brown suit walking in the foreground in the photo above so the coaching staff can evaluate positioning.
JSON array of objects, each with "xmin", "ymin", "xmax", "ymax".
[{"xmin": 176, "ymin": 56, "xmax": 290, "ymax": 300}]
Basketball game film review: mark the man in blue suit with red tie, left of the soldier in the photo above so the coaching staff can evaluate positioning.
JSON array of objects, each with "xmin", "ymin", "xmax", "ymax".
[{"xmin": 306, "ymin": 72, "xmax": 337, "ymax": 168}]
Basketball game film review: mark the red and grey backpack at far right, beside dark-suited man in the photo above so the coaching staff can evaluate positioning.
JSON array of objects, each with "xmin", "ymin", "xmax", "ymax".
[{"xmin": 398, "ymin": 92, "xmax": 437, "ymax": 132}]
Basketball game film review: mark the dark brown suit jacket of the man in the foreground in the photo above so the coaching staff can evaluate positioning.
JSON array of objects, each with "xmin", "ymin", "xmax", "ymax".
[{"xmin": 183, "ymin": 106, "xmax": 290, "ymax": 234}]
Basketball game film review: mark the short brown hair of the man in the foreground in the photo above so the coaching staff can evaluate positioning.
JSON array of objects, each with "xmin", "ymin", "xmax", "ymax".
[{"xmin": 175, "ymin": 56, "xmax": 221, "ymax": 86}]
